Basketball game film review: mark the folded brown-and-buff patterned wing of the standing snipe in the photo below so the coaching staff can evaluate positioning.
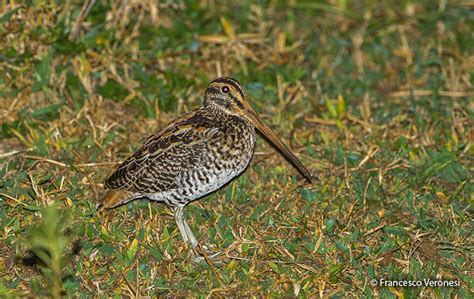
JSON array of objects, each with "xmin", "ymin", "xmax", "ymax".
[{"xmin": 105, "ymin": 110, "xmax": 219, "ymax": 193}]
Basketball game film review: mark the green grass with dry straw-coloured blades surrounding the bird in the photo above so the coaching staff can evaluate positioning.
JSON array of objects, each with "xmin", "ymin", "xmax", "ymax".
[{"xmin": 0, "ymin": 0, "xmax": 474, "ymax": 298}]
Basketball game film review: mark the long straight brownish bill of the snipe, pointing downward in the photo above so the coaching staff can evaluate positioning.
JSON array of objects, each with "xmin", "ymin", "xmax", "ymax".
[{"xmin": 244, "ymin": 102, "xmax": 311, "ymax": 182}]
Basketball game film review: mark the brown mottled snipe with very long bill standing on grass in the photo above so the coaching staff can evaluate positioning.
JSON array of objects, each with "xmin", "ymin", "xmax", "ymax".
[{"xmin": 97, "ymin": 77, "xmax": 312, "ymax": 261}]
